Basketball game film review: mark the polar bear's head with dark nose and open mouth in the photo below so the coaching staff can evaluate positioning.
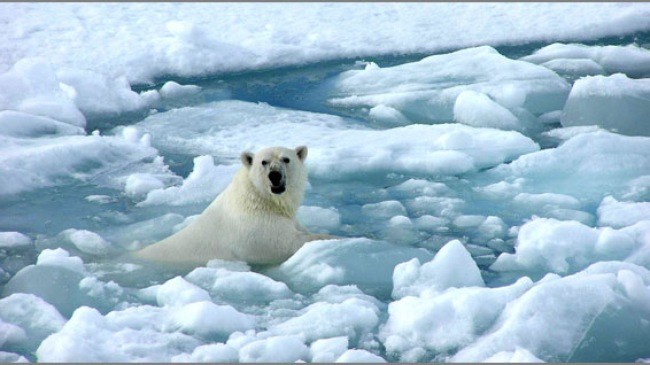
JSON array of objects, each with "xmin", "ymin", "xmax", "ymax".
[{"xmin": 241, "ymin": 146, "xmax": 307, "ymax": 202}]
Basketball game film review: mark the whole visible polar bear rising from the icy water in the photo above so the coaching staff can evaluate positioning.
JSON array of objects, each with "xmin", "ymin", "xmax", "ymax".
[{"xmin": 134, "ymin": 146, "xmax": 332, "ymax": 264}]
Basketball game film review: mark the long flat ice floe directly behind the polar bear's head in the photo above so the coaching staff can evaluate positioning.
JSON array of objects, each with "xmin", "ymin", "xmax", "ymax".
[{"xmin": 137, "ymin": 101, "xmax": 539, "ymax": 180}]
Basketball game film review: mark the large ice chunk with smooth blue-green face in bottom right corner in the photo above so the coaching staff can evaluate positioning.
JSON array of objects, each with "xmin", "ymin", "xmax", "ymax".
[{"xmin": 450, "ymin": 262, "xmax": 650, "ymax": 362}]
